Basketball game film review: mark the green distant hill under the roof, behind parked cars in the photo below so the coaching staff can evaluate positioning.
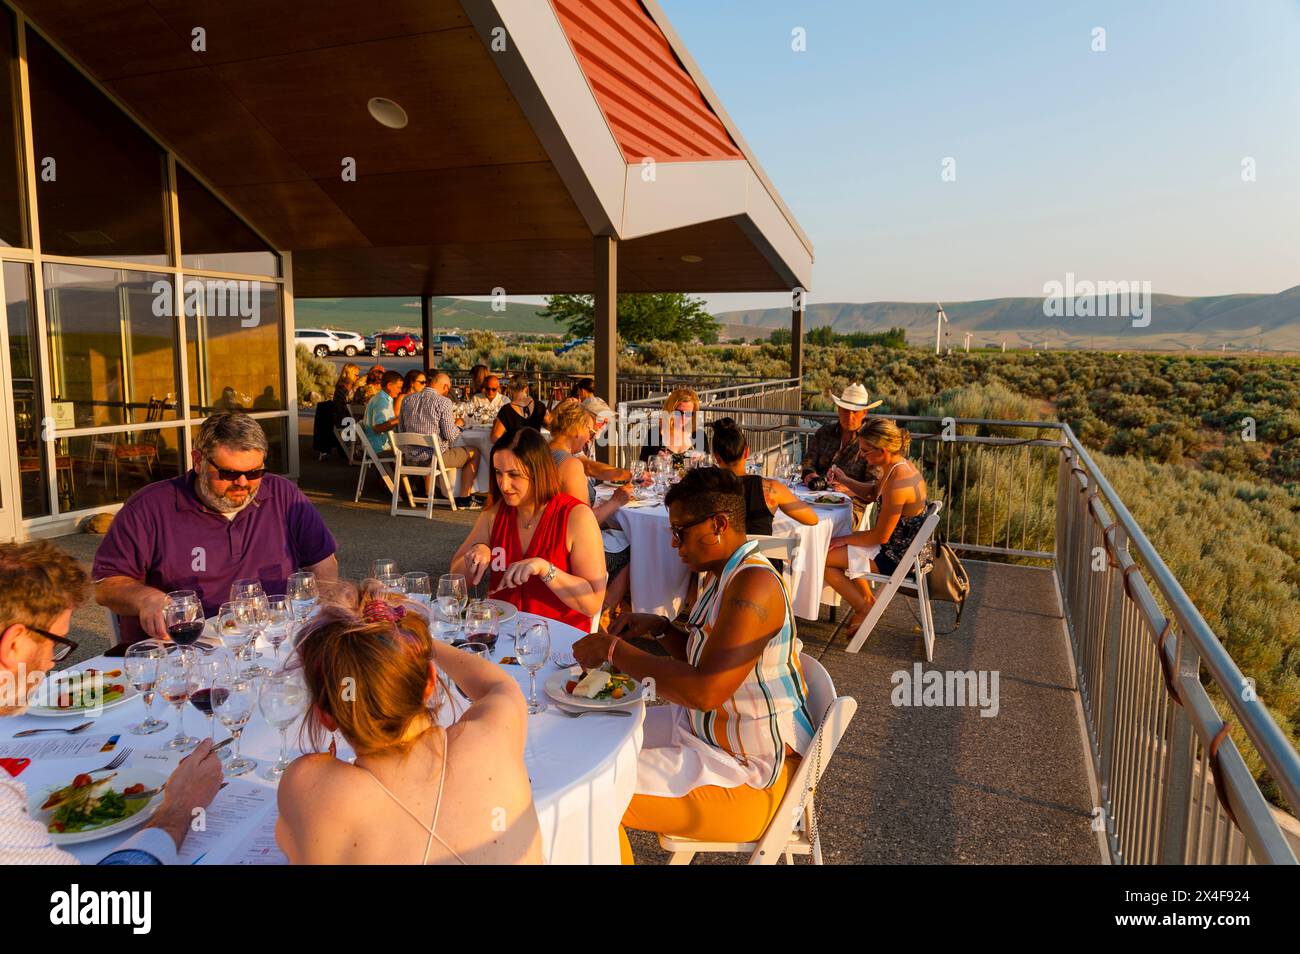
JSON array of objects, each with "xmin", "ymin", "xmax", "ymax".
[{"xmin": 294, "ymin": 298, "xmax": 564, "ymax": 334}]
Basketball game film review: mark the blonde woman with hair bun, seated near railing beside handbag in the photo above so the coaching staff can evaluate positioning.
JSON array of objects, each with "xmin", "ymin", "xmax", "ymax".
[{"xmin": 826, "ymin": 417, "xmax": 933, "ymax": 632}]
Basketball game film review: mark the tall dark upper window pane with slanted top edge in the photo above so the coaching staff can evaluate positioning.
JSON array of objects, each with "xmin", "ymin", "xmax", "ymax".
[{"xmin": 27, "ymin": 30, "xmax": 169, "ymax": 265}]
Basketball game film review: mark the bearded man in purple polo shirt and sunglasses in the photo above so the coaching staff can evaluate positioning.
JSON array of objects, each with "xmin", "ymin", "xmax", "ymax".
[{"xmin": 95, "ymin": 413, "xmax": 338, "ymax": 654}]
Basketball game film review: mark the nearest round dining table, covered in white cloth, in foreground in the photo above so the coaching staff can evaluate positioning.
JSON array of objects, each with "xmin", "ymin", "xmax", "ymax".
[{"xmin": 0, "ymin": 613, "xmax": 645, "ymax": 864}]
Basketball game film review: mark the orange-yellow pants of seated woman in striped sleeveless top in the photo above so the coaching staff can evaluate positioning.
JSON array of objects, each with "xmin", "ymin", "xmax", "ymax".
[{"xmin": 619, "ymin": 754, "xmax": 800, "ymax": 864}]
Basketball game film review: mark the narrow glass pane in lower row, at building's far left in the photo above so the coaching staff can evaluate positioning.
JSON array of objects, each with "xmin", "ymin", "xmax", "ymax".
[{"xmin": 4, "ymin": 261, "xmax": 46, "ymax": 519}]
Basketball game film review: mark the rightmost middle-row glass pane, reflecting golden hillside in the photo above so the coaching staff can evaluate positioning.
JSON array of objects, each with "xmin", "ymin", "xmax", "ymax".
[{"xmin": 183, "ymin": 276, "xmax": 285, "ymax": 417}]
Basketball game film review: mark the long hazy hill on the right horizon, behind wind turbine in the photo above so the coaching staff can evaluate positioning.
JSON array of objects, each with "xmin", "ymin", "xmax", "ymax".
[{"xmin": 716, "ymin": 286, "xmax": 1300, "ymax": 351}]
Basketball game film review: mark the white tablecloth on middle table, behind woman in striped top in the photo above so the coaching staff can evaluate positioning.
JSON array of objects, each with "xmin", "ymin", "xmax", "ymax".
[{"xmin": 615, "ymin": 504, "xmax": 853, "ymax": 620}]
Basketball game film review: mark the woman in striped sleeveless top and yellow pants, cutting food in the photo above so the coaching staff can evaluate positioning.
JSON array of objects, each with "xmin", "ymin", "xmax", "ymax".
[{"xmin": 573, "ymin": 468, "xmax": 814, "ymax": 863}]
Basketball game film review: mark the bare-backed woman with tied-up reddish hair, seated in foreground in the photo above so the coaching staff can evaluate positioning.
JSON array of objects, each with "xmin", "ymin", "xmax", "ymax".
[{"xmin": 276, "ymin": 590, "xmax": 542, "ymax": 864}]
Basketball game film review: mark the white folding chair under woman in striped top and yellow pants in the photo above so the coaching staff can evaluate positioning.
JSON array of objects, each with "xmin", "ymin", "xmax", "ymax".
[{"xmin": 659, "ymin": 652, "xmax": 858, "ymax": 864}]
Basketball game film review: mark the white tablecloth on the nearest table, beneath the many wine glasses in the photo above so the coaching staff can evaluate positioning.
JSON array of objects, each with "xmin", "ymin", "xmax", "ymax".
[{"xmin": 0, "ymin": 615, "xmax": 645, "ymax": 864}]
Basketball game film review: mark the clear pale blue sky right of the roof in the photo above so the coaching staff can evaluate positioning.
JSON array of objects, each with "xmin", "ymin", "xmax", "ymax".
[{"xmin": 659, "ymin": 0, "xmax": 1300, "ymax": 315}]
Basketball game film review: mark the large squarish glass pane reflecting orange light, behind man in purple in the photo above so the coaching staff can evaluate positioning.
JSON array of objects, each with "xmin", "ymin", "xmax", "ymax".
[{"xmin": 44, "ymin": 265, "xmax": 179, "ymax": 428}]
